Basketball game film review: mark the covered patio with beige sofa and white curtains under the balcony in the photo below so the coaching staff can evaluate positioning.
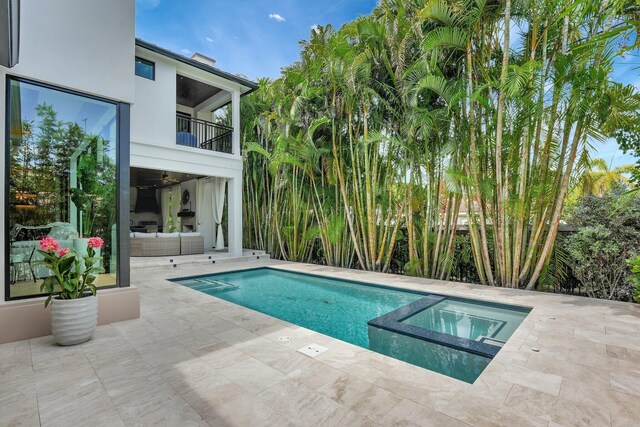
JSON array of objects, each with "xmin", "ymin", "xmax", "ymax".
[{"xmin": 129, "ymin": 167, "xmax": 237, "ymax": 258}]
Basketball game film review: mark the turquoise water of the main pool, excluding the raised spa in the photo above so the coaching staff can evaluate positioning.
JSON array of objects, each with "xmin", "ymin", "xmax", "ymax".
[{"xmin": 178, "ymin": 268, "xmax": 423, "ymax": 348}]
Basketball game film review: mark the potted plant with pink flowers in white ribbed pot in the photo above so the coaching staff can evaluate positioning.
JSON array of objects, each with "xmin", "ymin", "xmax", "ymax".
[{"xmin": 38, "ymin": 237, "xmax": 104, "ymax": 345}]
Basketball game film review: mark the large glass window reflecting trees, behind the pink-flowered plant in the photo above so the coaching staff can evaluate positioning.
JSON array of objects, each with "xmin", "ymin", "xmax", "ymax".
[{"xmin": 7, "ymin": 79, "xmax": 118, "ymax": 298}]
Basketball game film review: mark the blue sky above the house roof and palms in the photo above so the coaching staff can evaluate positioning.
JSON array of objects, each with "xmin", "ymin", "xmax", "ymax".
[{"xmin": 136, "ymin": 0, "xmax": 640, "ymax": 166}]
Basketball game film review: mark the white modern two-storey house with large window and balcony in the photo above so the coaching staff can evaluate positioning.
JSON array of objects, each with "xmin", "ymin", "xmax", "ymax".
[{"xmin": 0, "ymin": 0, "xmax": 257, "ymax": 343}]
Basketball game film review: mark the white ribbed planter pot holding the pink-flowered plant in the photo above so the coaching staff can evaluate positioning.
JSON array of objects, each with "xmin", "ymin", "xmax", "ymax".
[{"xmin": 51, "ymin": 295, "xmax": 98, "ymax": 345}]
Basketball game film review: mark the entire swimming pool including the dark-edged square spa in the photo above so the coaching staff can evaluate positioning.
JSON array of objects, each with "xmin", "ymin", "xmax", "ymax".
[{"xmin": 174, "ymin": 267, "xmax": 529, "ymax": 383}]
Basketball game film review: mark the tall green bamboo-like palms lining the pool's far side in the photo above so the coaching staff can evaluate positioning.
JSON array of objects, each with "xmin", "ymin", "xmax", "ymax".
[{"xmin": 241, "ymin": 0, "xmax": 640, "ymax": 289}]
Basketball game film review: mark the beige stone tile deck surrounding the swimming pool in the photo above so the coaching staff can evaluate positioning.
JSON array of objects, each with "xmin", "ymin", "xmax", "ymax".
[{"xmin": 0, "ymin": 260, "xmax": 640, "ymax": 426}]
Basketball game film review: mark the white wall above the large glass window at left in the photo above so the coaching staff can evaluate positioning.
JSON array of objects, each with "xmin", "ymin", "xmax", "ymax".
[{"xmin": 0, "ymin": 0, "xmax": 135, "ymax": 310}]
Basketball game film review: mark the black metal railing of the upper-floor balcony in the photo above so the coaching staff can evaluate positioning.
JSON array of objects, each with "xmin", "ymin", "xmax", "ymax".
[{"xmin": 176, "ymin": 115, "xmax": 233, "ymax": 153}]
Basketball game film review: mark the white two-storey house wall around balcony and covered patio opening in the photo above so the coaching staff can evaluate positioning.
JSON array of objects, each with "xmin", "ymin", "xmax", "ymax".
[{"xmin": 130, "ymin": 47, "xmax": 243, "ymax": 255}]
